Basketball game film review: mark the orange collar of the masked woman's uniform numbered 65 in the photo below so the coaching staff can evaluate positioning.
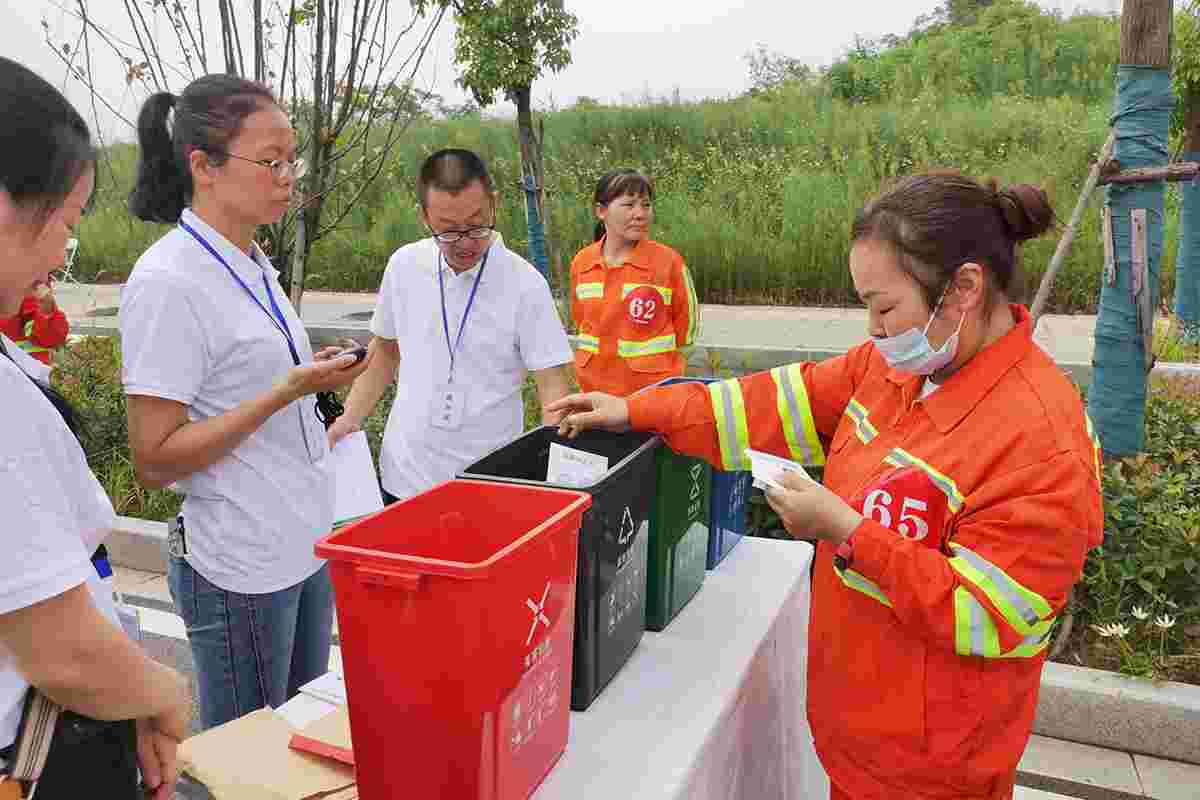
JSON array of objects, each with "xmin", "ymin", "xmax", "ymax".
[{"xmin": 888, "ymin": 303, "xmax": 1033, "ymax": 433}]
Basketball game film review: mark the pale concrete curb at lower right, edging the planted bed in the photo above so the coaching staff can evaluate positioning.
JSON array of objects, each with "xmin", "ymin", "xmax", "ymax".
[{"xmin": 1033, "ymin": 663, "xmax": 1200, "ymax": 764}]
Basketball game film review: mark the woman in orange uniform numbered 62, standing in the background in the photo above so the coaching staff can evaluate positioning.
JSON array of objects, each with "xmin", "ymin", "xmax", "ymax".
[{"xmin": 571, "ymin": 169, "xmax": 700, "ymax": 396}]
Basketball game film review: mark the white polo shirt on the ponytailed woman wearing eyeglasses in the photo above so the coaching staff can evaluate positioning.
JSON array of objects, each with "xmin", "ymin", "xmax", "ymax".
[{"xmin": 120, "ymin": 210, "xmax": 334, "ymax": 594}]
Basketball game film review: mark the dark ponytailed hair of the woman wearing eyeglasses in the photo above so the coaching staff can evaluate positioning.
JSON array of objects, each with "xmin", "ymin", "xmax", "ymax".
[{"xmin": 130, "ymin": 74, "xmax": 275, "ymax": 223}]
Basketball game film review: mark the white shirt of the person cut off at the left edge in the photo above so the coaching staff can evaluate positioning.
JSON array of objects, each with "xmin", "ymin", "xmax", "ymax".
[{"xmin": 0, "ymin": 338, "xmax": 116, "ymax": 763}]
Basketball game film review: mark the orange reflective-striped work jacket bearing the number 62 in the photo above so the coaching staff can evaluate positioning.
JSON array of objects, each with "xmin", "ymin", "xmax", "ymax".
[{"xmin": 571, "ymin": 240, "xmax": 700, "ymax": 397}]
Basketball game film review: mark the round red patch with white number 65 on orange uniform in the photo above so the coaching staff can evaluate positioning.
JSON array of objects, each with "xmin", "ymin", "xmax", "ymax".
[{"xmin": 851, "ymin": 467, "xmax": 949, "ymax": 551}]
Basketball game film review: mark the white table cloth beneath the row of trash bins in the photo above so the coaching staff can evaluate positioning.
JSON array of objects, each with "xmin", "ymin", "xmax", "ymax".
[{"xmin": 278, "ymin": 539, "xmax": 829, "ymax": 800}]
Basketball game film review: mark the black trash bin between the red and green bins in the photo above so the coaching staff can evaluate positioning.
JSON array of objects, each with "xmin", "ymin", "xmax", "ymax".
[{"xmin": 460, "ymin": 427, "xmax": 661, "ymax": 711}]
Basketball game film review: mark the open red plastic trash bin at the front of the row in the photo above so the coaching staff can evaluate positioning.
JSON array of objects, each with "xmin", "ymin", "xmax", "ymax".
[{"xmin": 316, "ymin": 480, "xmax": 592, "ymax": 800}]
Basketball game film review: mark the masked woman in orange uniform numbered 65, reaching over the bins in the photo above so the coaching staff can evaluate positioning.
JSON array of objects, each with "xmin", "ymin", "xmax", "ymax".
[{"xmin": 548, "ymin": 173, "xmax": 1104, "ymax": 800}]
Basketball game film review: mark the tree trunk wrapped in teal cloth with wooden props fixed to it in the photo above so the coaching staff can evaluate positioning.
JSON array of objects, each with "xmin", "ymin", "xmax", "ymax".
[{"xmin": 1087, "ymin": 0, "xmax": 1175, "ymax": 457}]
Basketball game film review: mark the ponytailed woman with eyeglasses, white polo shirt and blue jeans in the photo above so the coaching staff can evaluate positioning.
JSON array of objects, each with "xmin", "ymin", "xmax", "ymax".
[{"xmin": 120, "ymin": 76, "xmax": 366, "ymax": 727}]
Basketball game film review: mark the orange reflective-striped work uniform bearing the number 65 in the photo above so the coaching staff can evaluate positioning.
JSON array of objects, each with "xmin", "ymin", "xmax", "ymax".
[{"xmin": 629, "ymin": 306, "xmax": 1104, "ymax": 800}]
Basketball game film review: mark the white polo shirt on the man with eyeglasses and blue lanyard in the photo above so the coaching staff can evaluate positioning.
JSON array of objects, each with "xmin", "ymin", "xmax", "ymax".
[{"xmin": 371, "ymin": 239, "xmax": 574, "ymax": 498}]
